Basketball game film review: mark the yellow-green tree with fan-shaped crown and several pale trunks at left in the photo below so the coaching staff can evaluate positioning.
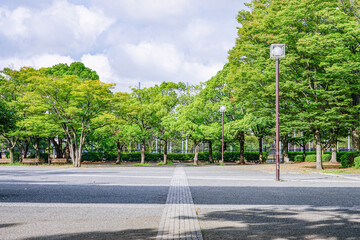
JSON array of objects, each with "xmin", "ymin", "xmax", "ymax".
[{"xmin": 34, "ymin": 75, "xmax": 113, "ymax": 167}]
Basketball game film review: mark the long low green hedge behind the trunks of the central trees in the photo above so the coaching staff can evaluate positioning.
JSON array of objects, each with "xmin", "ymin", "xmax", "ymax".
[{"xmin": 81, "ymin": 151, "xmax": 268, "ymax": 162}]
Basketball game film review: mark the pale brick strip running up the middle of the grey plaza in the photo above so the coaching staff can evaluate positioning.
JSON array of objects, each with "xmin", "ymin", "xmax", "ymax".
[{"xmin": 156, "ymin": 166, "xmax": 203, "ymax": 240}]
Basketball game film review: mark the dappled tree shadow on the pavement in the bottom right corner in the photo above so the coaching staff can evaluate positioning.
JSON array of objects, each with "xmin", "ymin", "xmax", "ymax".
[{"xmin": 199, "ymin": 209, "xmax": 360, "ymax": 240}]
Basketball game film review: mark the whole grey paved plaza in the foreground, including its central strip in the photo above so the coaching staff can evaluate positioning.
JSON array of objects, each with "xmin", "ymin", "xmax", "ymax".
[{"xmin": 0, "ymin": 165, "xmax": 360, "ymax": 240}]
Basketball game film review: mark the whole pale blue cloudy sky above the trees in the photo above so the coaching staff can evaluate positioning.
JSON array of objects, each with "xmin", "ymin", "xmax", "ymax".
[{"xmin": 0, "ymin": 0, "xmax": 250, "ymax": 91}]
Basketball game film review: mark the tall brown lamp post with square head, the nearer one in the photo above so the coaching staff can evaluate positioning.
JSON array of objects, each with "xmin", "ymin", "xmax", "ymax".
[{"xmin": 270, "ymin": 44, "xmax": 285, "ymax": 181}]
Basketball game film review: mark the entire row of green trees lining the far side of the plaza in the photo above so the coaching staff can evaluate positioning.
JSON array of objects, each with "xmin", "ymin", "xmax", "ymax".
[{"xmin": 0, "ymin": 0, "xmax": 360, "ymax": 168}]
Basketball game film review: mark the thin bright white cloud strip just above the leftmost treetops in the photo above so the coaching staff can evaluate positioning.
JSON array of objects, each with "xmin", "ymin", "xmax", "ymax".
[{"xmin": 0, "ymin": 54, "xmax": 74, "ymax": 69}]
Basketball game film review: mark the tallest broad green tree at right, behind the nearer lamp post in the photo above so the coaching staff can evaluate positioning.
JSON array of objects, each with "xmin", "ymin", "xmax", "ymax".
[{"xmin": 229, "ymin": 0, "xmax": 359, "ymax": 169}]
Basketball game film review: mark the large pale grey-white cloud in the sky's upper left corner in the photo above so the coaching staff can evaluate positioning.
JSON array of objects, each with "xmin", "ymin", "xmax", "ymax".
[{"xmin": 0, "ymin": 0, "xmax": 114, "ymax": 54}]
